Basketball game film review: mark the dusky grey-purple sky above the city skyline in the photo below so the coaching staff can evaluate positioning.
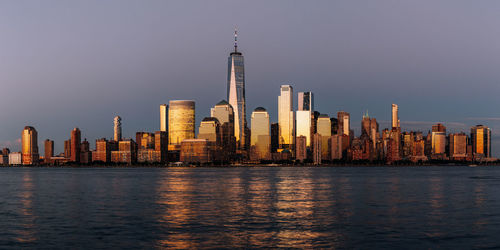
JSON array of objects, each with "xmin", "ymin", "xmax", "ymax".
[{"xmin": 0, "ymin": 0, "xmax": 500, "ymax": 157}]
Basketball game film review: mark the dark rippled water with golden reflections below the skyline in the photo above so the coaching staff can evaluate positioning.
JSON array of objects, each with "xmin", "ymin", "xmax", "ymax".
[{"xmin": 0, "ymin": 167, "xmax": 500, "ymax": 249}]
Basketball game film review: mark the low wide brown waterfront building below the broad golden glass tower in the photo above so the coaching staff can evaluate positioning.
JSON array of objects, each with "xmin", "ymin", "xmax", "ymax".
[{"xmin": 180, "ymin": 139, "xmax": 213, "ymax": 163}]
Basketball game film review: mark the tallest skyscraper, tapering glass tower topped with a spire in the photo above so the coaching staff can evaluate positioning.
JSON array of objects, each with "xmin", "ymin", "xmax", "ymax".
[{"xmin": 227, "ymin": 30, "xmax": 248, "ymax": 150}]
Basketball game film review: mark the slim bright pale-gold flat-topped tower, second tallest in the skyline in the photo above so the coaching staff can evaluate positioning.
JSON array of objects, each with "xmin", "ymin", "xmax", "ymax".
[{"xmin": 278, "ymin": 85, "xmax": 295, "ymax": 151}]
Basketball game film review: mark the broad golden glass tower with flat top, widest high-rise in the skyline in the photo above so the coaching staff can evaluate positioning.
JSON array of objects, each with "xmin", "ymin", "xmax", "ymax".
[{"xmin": 168, "ymin": 100, "xmax": 195, "ymax": 150}]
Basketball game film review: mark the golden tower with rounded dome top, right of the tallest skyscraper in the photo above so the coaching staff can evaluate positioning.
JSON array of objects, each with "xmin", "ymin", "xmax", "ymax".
[{"xmin": 250, "ymin": 107, "xmax": 271, "ymax": 160}]
